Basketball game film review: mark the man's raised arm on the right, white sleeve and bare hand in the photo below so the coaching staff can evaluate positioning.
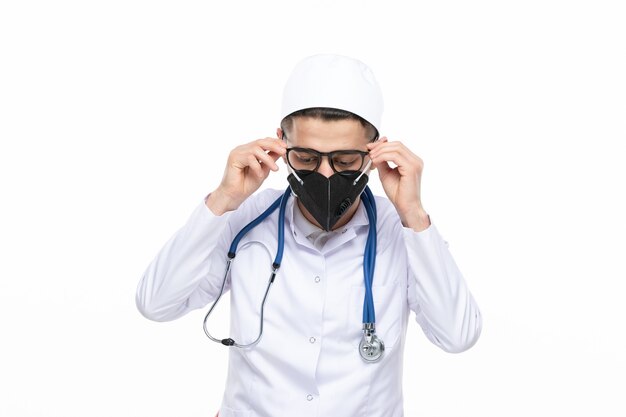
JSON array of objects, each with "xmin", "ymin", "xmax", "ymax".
[{"xmin": 368, "ymin": 137, "xmax": 482, "ymax": 352}]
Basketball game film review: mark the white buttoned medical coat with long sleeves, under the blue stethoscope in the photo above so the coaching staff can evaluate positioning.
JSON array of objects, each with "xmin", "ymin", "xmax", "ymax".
[{"xmin": 137, "ymin": 190, "xmax": 482, "ymax": 417}]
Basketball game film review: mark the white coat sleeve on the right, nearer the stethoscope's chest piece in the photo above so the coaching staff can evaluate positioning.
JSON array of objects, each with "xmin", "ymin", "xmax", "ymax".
[{"xmin": 402, "ymin": 224, "xmax": 482, "ymax": 353}]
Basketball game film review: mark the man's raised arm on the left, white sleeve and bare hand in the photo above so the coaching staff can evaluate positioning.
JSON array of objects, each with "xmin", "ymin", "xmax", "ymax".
[{"xmin": 136, "ymin": 138, "xmax": 285, "ymax": 321}]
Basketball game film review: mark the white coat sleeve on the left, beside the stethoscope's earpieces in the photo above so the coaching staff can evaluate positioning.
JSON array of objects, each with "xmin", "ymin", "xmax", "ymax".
[{"xmin": 135, "ymin": 201, "xmax": 231, "ymax": 321}]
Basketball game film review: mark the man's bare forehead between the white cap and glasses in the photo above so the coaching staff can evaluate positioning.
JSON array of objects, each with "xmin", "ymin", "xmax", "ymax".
[{"xmin": 287, "ymin": 117, "xmax": 368, "ymax": 152}]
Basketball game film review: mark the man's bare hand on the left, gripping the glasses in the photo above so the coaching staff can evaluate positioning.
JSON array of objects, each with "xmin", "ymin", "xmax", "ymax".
[{"xmin": 206, "ymin": 137, "xmax": 287, "ymax": 216}]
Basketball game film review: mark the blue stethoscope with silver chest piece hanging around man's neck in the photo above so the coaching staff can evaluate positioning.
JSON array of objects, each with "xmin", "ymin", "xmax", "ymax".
[{"xmin": 203, "ymin": 187, "xmax": 385, "ymax": 362}]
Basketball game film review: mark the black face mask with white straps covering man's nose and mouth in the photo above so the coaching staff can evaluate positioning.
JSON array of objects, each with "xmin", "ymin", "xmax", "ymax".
[{"xmin": 287, "ymin": 171, "xmax": 368, "ymax": 232}]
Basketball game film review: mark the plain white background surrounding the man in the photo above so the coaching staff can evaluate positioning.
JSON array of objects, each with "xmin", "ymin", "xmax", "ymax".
[{"xmin": 0, "ymin": 0, "xmax": 626, "ymax": 417}]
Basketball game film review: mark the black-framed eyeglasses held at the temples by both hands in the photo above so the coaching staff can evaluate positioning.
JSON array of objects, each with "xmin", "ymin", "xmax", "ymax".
[{"xmin": 287, "ymin": 148, "xmax": 368, "ymax": 174}]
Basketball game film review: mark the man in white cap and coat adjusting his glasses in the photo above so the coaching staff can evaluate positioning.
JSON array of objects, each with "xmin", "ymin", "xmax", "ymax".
[{"xmin": 137, "ymin": 55, "xmax": 482, "ymax": 417}]
